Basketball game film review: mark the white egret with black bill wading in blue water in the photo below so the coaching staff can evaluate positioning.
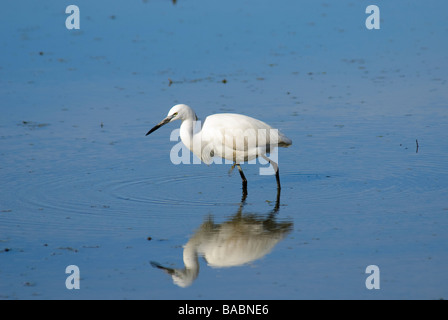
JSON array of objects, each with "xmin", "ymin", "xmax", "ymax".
[{"xmin": 146, "ymin": 104, "xmax": 292, "ymax": 189}]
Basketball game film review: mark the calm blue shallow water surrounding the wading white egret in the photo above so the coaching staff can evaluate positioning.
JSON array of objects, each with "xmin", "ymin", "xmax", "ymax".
[{"xmin": 0, "ymin": 0, "xmax": 448, "ymax": 299}]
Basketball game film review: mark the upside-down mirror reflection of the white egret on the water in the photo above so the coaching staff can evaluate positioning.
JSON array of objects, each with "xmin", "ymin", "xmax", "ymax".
[{"xmin": 151, "ymin": 193, "xmax": 292, "ymax": 287}]
